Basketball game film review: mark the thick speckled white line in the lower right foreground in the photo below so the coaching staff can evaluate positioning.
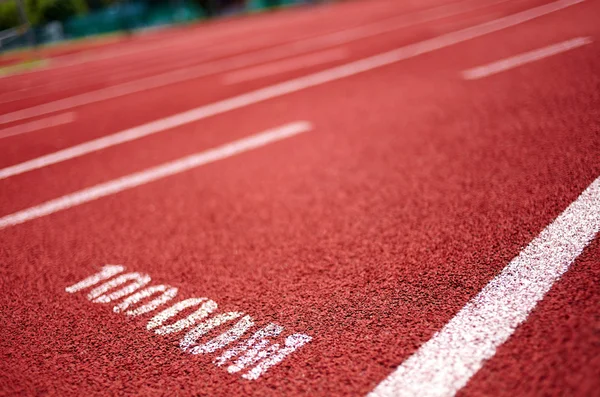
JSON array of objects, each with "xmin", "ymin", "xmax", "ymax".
[{"xmin": 368, "ymin": 178, "xmax": 600, "ymax": 397}]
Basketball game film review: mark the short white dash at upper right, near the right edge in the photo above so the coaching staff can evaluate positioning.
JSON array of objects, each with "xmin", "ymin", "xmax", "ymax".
[{"xmin": 462, "ymin": 37, "xmax": 592, "ymax": 80}]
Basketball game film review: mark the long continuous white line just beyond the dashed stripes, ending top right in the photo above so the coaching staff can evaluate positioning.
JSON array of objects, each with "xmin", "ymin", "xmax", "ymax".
[{"xmin": 0, "ymin": 0, "xmax": 584, "ymax": 179}]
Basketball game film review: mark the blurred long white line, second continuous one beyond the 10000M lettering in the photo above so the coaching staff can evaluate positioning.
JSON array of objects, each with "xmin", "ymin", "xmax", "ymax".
[{"xmin": 0, "ymin": 0, "xmax": 508, "ymax": 124}]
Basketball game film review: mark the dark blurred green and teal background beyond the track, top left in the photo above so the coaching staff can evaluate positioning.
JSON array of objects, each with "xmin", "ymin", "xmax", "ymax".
[{"xmin": 0, "ymin": 0, "xmax": 318, "ymax": 54}]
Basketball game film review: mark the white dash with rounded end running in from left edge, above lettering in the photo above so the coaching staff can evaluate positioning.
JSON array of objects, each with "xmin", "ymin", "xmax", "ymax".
[{"xmin": 0, "ymin": 121, "xmax": 312, "ymax": 229}]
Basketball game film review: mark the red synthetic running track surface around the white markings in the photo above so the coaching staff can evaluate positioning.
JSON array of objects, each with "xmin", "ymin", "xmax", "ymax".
[{"xmin": 0, "ymin": 0, "xmax": 600, "ymax": 396}]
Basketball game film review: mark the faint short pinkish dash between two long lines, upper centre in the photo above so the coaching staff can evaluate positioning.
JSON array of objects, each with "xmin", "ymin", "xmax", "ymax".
[{"xmin": 223, "ymin": 48, "xmax": 349, "ymax": 84}]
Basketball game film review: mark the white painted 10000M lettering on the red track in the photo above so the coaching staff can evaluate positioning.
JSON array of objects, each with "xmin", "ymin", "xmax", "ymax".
[{"xmin": 65, "ymin": 265, "xmax": 312, "ymax": 380}]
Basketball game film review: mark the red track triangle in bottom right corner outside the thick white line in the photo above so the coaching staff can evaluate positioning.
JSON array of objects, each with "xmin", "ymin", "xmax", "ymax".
[{"xmin": 457, "ymin": 237, "xmax": 600, "ymax": 397}]
